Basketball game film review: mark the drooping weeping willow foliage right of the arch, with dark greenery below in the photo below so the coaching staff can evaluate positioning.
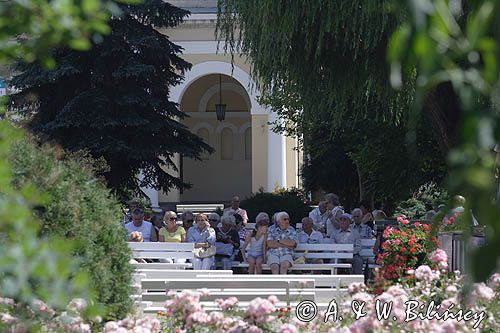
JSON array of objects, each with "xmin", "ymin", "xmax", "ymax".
[{"xmin": 217, "ymin": 0, "xmax": 444, "ymax": 206}]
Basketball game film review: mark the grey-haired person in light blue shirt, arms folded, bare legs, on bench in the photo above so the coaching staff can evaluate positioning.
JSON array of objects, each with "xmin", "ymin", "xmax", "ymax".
[{"xmin": 267, "ymin": 212, "xmax": 298, "ymax": 274}]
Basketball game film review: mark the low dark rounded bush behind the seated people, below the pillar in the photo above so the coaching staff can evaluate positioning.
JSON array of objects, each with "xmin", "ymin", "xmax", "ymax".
[{"xmin": 241, "ymin": 189, "xmax": 310, "ymax": 225}]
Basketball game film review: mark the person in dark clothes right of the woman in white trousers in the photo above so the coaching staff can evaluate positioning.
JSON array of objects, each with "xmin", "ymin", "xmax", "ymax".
[{"xmin": 215, "ymin": 215, "xmax": 240, "ymax": 270}]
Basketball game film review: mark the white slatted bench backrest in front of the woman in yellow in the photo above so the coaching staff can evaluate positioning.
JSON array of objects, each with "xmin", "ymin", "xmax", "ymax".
[{"xmin": 128, "ymin": 242, "xmax": 194, "ymax": 265}]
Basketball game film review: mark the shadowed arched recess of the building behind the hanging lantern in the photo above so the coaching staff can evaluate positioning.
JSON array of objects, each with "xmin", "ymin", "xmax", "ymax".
[{"xmin": 180, "ymin": 74, "xmax": 252, "ymax": 203}]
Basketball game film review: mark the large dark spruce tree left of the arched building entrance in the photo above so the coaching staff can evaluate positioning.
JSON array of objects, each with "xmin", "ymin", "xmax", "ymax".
[{"xmin": 10, "ymin": 0, "xmax": 212, "ymax": 197}]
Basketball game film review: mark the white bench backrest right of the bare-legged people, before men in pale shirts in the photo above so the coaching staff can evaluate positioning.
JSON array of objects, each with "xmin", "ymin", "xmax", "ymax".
[{"xmin": 295, "ymin": 244, "xmax": 354, "ymax": 260}]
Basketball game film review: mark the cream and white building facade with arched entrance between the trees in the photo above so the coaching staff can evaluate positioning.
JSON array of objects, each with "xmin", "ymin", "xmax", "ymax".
[{"xmin": 143, "ymin": 0, "xmax": 302, "ymax": 209}]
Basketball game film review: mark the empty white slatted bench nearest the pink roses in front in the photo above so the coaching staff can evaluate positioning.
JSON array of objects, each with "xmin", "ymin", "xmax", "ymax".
[{"xmin": 141, "ymin": 276, "xmax": 315, "ymax": 312}]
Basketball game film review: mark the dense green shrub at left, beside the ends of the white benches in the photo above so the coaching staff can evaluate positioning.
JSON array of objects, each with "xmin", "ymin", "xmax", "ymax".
[{"xmin": 11, "ymin": 140, "xmax": 132, "ymax": 318}]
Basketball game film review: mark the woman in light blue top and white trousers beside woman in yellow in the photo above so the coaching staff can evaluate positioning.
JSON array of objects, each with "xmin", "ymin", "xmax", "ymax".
[{"xmin": 186, "ymin": 214, "xmax": 215, "ymax": 270}]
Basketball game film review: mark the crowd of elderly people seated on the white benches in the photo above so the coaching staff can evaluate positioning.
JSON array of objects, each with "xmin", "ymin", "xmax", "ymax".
[{"xmin": 125, "ymin": 193, "xmax": 385, "ymax": 274}]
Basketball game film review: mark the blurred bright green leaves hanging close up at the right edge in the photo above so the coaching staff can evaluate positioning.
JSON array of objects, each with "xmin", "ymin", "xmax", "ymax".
[{"xmin": 388, "ymin": 0, "xmax": 500, "ymax": 280}]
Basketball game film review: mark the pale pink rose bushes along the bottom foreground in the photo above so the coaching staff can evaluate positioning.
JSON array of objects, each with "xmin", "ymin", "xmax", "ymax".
[{"xmin": 154, "ymin": 250, "xmax": 500, "ymax": 333}]
